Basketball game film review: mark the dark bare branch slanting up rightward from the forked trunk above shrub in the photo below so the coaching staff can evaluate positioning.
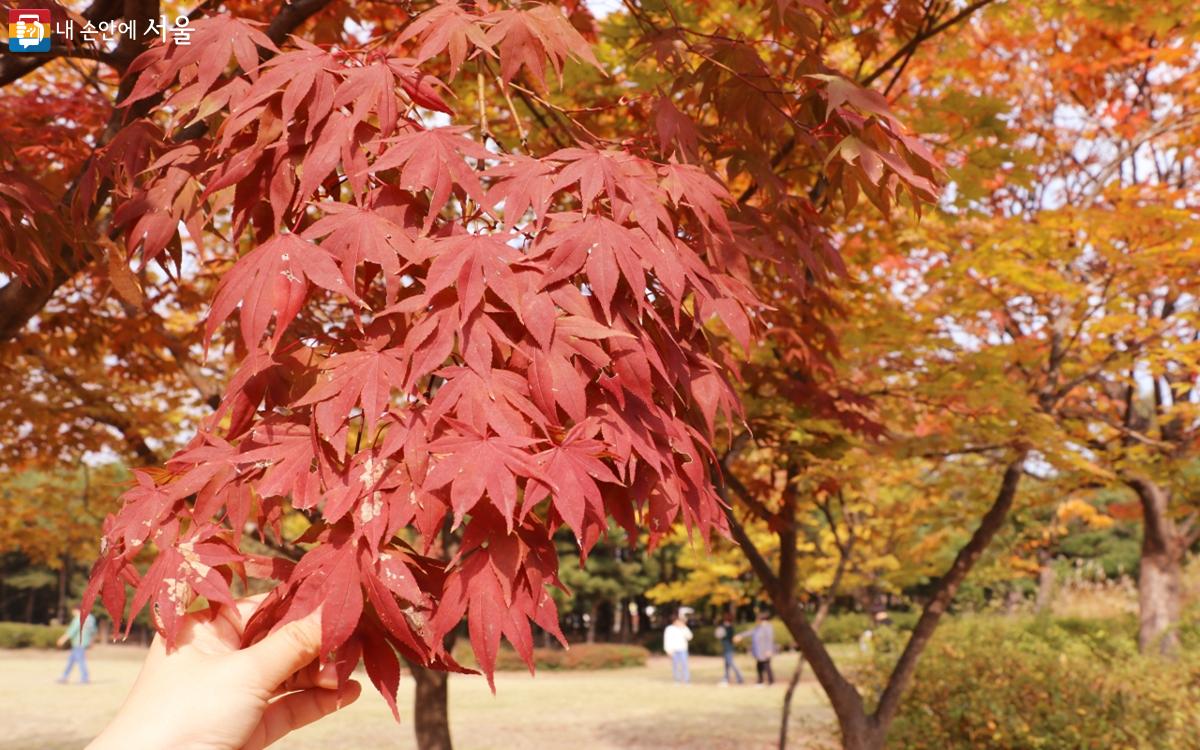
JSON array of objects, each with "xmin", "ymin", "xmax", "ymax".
[{"xmin": 875, "ymin": 450, "xmax": 1025, "ymax": 726}]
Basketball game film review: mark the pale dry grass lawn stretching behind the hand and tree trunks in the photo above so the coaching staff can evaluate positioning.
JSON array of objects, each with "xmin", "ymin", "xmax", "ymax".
[{"xmin": 0, "ymin": 646, "xmax": 833, "ymax": 750}]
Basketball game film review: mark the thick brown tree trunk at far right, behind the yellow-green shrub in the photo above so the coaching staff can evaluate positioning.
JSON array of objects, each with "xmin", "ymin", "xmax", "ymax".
[{"xmin": 1129, "ymin": 478, "xmax": 1187, "ymax": 656}]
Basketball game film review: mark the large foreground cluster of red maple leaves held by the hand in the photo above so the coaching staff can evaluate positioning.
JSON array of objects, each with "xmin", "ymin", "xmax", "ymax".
[{"xmin": 82, "ymin": 4, "xmax": 754, "ymax": 704}]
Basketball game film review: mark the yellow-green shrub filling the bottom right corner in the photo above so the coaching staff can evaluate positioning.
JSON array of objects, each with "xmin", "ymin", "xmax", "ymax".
[{"xmin": 869, "ymin": 617, "xmax": 1200, "ymax": 750}]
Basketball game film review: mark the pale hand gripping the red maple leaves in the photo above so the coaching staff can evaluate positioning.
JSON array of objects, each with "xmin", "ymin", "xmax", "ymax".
[{"xmin": 88, "ymin": 596, "xmax": 361, "ymax": 750}]
